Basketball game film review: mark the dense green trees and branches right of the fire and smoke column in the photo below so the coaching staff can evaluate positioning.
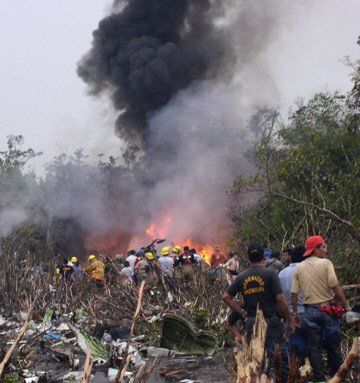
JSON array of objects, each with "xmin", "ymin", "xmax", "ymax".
[{"xmin": 229, "ymin": 58, "xmax": 360, "ymax": 282}]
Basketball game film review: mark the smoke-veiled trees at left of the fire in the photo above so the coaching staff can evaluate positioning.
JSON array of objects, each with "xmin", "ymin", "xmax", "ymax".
[{"xmin": 0, "ymin": 141, "xmax": 150, "ymax": 256}]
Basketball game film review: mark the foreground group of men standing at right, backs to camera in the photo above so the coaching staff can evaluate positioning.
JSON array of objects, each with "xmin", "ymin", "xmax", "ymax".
[{"xmin": 223, "ymin": 236, "xmax": 351, "ymax": 383}]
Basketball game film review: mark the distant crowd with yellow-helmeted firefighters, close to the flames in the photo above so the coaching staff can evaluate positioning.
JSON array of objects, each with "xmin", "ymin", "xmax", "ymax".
[{"xmin": 56, "ymin": 245, "xmax": 292, "ymax": 287}]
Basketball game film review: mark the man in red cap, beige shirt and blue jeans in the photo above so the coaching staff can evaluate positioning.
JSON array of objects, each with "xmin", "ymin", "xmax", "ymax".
[{"xmin": 291, "ymin": 235, "xmax": 350, "ymax": 382}]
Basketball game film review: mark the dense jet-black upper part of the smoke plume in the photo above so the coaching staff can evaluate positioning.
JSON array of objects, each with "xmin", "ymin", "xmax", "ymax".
[{"xmin": 78, "ymin": 0, "xmax": 232, "ymax": 148}]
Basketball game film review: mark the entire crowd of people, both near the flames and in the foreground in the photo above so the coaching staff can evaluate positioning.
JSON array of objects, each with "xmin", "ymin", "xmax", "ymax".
[{"xmin": 57, "ymin": 236, "xmax": 350, "ymax": 382}]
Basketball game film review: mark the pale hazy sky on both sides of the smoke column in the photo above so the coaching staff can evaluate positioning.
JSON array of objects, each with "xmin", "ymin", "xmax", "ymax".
[{"xmin": 0, "ymin": 0, "xmax": 360, "ymax": 172}]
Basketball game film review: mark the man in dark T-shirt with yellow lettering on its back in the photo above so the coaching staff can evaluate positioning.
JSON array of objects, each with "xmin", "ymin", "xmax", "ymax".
[{"xmin": 223, "ymin": 244, "xmax": 294, "ymax": 383}]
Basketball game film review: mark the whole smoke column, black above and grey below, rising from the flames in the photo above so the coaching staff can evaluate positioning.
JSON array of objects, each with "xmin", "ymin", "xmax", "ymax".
[{"xmin": 78, "ymin": 0, "xmax": 280, "ymax": 243}]
